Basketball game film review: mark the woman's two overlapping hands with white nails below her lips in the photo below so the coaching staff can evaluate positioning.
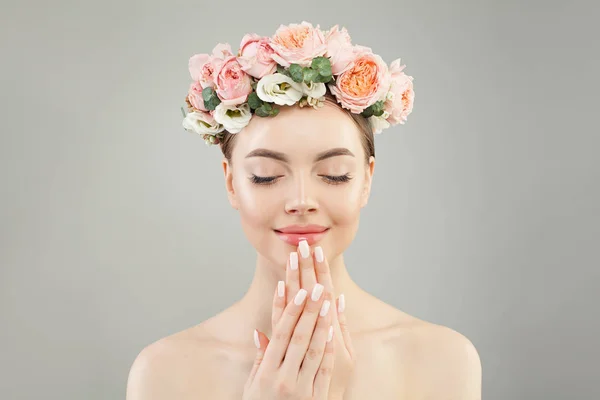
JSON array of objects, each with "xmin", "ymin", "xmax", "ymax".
[{"xmin": 243, "ymin": 240, "xmax": 354, "ymax": 400}]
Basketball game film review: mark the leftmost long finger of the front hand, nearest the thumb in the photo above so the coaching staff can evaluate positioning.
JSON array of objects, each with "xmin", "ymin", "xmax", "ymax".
[{"xmin": 263, "ymin": 289, "xmax": 308, "ymax": 370}]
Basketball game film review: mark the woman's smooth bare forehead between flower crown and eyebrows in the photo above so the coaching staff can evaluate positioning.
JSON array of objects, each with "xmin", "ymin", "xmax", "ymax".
[{"xmin": 233, "ymin": 102, "xmax": 363, "ymax": 160}]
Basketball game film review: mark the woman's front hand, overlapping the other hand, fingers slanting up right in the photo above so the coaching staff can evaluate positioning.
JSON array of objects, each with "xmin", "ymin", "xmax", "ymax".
[{"xmin": 242, "ymin": 284, "xmax": 334, "ymax": 400}]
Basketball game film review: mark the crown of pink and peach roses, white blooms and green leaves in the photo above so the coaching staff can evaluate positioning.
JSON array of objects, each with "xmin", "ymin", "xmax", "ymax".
[{"xmin": 181, "ymin": 21, "xmax": 415, "ymax": 145}]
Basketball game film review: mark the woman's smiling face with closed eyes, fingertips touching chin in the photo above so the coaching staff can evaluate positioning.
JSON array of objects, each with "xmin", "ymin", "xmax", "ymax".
[{"xmin": 223, "ymin": 102, "xmax": 375, "ymax": 268}]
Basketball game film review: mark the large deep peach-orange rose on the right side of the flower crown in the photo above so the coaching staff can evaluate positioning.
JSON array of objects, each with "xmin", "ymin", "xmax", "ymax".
[{"xmin": 329, "ymin": 46, "xmax": 390, "ymax": 114}]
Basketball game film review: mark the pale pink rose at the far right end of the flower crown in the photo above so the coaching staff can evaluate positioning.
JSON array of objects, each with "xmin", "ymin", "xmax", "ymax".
[{"xmin": 384, "ymin": 59, "xmax": 415, "ymax": 125}]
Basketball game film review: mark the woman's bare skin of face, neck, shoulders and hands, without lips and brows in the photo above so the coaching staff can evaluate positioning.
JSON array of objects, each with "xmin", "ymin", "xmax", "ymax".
[{"xmin": 127, "ymin": 102, "xmax": 481, "ymax": 400}]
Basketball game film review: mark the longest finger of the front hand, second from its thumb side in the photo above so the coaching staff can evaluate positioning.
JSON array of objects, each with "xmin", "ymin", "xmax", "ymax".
[{"xmin": 281, "ymin": 284, "xmax": 331, "ymax": 378}]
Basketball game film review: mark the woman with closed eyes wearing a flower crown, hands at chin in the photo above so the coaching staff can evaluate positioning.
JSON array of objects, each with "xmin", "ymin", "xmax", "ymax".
[{"xmin": 127, "ymin": 22, "xmax": 481, "ymax": 400}]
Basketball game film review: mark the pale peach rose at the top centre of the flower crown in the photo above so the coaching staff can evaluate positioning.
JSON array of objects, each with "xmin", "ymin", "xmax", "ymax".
[{"xmin": 270, "ymin": 21, "xmax": 327, "ymax": 68}]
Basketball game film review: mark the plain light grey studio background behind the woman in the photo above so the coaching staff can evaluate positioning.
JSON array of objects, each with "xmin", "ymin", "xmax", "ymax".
[{"xmin": 0, "ymin": 0, "xmax": 600, "ymax": 400}]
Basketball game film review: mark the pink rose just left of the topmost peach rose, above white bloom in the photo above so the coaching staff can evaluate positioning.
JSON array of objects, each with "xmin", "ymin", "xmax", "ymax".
[{"xmin": 238, "ymin": 34, "xmax": 277, "ymax": 79}]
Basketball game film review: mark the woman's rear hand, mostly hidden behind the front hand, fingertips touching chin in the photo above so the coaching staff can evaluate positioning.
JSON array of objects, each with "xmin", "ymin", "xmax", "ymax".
[{"xmin": 272, "ymin": 241, "xmax": 355, "ymax": 398}]
